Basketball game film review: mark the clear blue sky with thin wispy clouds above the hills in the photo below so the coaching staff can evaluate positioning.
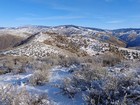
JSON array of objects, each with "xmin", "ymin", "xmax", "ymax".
[{"xmin": 0, "ymin": 0, "xmax": 140, "ymax": 29}]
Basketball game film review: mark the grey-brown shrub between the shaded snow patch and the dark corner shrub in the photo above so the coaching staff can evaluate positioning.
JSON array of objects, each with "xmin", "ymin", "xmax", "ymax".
[{"xmin": 58, "ymin": 64, "xmax": 106, "ymax": 98}]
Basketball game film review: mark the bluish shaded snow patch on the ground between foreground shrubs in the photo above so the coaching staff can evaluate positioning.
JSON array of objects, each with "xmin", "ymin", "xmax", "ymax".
[{"xmin": 0, "ymin": 66, "xmax": 84, "ymax": 105}]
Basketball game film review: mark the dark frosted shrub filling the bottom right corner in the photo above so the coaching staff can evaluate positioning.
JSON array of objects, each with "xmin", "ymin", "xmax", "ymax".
[{"xmin": 84, "ymin": 69, "xmax": 140, "ymax": 105}]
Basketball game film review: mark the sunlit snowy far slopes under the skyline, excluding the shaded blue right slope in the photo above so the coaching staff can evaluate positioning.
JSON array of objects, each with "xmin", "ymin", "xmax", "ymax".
[{"xmin": 0, "ymin": 25, "xmax": 125, "ymax": 46}]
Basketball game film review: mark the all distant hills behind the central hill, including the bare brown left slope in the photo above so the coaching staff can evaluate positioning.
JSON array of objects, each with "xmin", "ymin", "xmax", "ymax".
[{"xmin": 0, "ymin": 25, "xmax": 140, "ymax": 49}]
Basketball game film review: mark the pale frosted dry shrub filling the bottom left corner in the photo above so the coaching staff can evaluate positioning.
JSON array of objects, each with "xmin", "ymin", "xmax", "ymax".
[{"xmin": 0, "ymin": 85, "xmax": 51, "ymax": 105}]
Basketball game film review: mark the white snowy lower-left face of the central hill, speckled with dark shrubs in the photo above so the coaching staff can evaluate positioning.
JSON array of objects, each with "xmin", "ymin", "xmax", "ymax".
[{"xmin": 3, "ymin": 42, "xmax": 69, "ymax": 58}]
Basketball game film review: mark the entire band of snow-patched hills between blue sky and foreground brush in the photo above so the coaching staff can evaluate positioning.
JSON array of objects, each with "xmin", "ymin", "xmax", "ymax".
[{"xmin": 0, "ymin": 25, "xmax": 140, "ymax": 58}]
